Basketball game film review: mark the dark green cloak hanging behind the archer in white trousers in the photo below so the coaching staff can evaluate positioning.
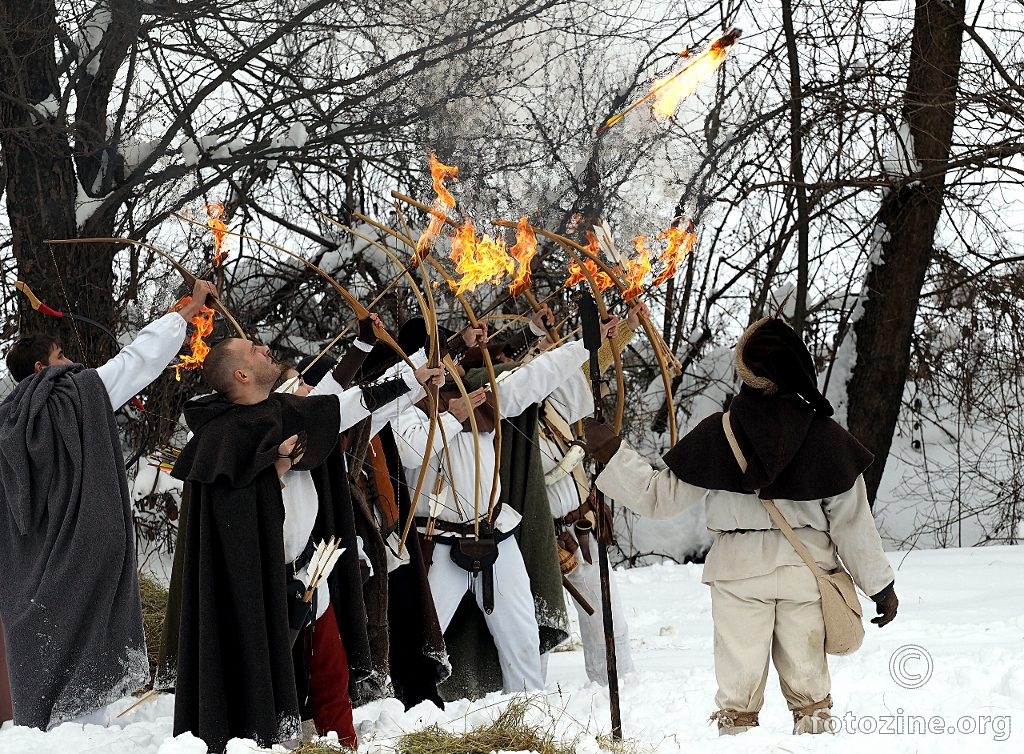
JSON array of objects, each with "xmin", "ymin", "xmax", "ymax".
[{"xmin": 441, "ymin": 368, "xmax": 568, "ymax": 701}]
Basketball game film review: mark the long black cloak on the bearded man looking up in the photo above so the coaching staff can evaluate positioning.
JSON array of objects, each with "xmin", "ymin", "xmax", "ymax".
[{"xmin": 172, "ymin": 393, "xmax": 340, "ymax": 751}]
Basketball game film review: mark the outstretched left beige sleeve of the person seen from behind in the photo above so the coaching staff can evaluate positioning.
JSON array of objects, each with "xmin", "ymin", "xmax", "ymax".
[{"xmin": 597, "ymin": 443, "xmax": 708, "ymax": 518}]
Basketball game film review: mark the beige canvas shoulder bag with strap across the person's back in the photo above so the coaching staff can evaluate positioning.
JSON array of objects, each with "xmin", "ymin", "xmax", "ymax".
[{"xmin": 722, "ymin": 412, "xmax": 864, "ymax": 655}]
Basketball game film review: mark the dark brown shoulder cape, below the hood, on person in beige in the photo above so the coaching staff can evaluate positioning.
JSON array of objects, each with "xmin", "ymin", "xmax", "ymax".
[{"xmin": 665, "ymin": 385, "xmax": 873, "ymax": 500}]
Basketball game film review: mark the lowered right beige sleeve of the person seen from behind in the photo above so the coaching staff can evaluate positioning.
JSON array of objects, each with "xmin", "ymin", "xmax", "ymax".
[{"xmin": 822, "ymin": 476, "xmax": 896, "ymax": 595}]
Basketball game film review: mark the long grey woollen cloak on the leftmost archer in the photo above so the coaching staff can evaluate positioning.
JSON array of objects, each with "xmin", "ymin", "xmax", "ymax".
[{"xmin": 0, "ymin": 364, "xmax": 148, "ymax": 728}]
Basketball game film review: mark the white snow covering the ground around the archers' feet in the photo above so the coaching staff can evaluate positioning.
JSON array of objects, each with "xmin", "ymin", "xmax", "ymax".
[{"xmin": 0, "ymin": 546, "xmax": 1024, "ymax": 754}]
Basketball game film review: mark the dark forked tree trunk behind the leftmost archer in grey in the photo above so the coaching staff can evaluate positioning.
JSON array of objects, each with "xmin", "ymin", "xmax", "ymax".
[{"xmin": 0, "ymin": 0, "xmax": 131, "ymax": 365}]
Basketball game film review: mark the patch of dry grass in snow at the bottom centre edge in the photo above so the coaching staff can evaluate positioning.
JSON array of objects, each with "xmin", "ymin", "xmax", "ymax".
[{"xmin": 396, "ymin": 697, "xmax": 575, "ymax": 754}]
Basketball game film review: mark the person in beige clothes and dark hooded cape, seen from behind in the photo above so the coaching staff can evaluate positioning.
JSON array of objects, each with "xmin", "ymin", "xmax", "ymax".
[{"xmin": 587, "ymin": 318, "xmax": 899, "ymax": 735}]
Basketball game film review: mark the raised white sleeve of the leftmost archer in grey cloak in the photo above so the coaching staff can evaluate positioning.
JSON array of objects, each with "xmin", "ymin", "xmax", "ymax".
[{"xmin": 96, "ymin": 311, "xmax": 188, "ymax": 410}]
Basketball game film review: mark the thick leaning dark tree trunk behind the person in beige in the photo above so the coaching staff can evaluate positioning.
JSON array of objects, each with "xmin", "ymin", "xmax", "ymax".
[{"xmin": 847, "ymin": 0, "xmax": 965, "ymax": 504}]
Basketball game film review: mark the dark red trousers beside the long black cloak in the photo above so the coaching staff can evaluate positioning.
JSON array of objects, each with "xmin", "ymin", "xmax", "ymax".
[{"xmin": 306, "ymin": 604, "xmax": 358, "ymax": 749}]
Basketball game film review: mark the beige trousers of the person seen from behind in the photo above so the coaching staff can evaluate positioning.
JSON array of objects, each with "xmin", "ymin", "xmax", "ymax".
[{"xmin": 711, "ymin": 566, "xmax": 831, "ymax": 712}]
